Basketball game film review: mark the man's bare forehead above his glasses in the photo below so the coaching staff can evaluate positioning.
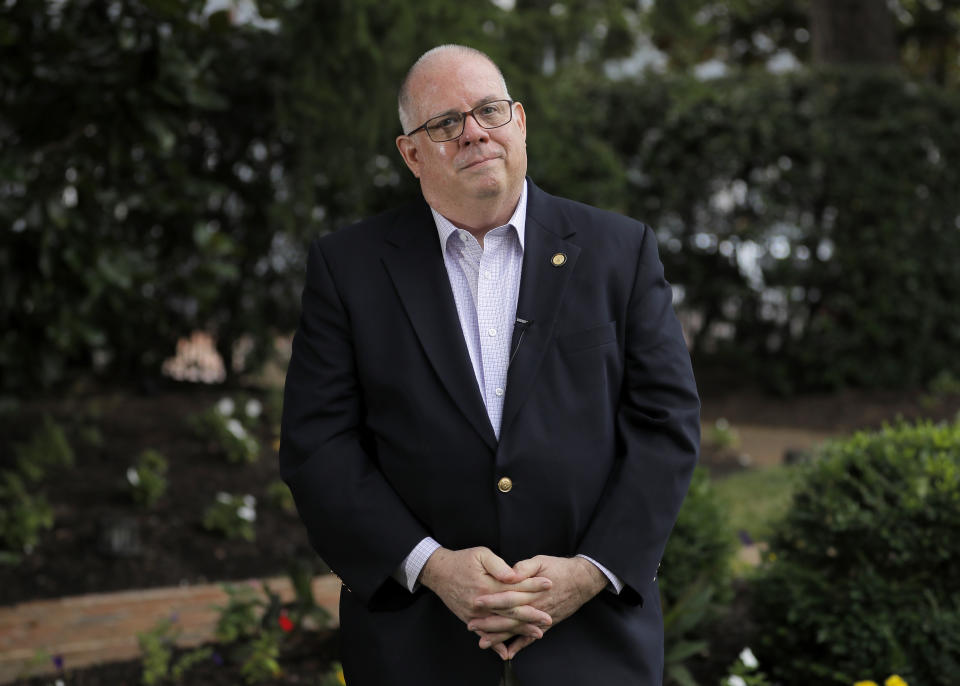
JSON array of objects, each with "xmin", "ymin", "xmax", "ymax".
[{"xmin": 410, "ymin": 54, "xmax": 507, "ymax": 118}]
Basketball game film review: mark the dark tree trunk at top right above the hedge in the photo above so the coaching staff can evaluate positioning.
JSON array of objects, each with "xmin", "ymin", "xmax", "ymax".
[{"xmin": 810, "ymin": 0, "xmax": 898, "ymax": 65}]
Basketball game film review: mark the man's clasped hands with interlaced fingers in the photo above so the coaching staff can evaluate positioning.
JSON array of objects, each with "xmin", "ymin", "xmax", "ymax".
[{"xmin": 420, "ymin": 547, "xmax": 607, "ymax": 660}]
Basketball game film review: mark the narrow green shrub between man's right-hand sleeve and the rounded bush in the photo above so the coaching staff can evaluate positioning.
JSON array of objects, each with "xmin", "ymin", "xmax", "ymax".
[{"xmin": 658, "ymin": 467, "xmax": 734, "ymax": 686}]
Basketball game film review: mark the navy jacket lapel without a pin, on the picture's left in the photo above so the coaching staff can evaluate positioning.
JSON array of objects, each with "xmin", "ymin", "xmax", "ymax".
[{"xmin": 383, "ymin": 203, "xmax": 497, "ymax": 450}]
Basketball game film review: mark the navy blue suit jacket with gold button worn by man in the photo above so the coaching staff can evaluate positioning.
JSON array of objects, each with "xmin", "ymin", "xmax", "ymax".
[{"xmin": 280, "ymin": 180, "xmax": 699, "ymax": 686}]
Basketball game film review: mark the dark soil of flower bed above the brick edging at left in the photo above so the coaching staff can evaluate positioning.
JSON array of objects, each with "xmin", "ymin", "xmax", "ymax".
[{"xmin": 0, "ymin": 386, "xmax": 326, "ymax": 605}]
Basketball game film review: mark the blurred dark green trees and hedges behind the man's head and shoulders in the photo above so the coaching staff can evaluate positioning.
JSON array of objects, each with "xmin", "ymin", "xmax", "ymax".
[{"xmin": 0, "ymin": 0, "xmax": 960, "ymax": 396}]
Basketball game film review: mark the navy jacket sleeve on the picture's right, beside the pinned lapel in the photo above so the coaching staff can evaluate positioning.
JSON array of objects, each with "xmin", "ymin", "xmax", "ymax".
[{"xmin": 578, "ymin": 226, "xmax": 700, "ymax": 604}]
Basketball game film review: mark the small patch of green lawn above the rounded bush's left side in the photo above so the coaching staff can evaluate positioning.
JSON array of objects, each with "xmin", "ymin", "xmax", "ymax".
[{"xmin": 712, "ymin": 465, "xmax": 798, "ymax": 541}]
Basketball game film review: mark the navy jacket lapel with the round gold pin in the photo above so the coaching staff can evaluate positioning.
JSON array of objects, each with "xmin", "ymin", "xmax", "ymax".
[{"xmin": 500, "ymin": 179, "xmax": 580, "ymax": 436}]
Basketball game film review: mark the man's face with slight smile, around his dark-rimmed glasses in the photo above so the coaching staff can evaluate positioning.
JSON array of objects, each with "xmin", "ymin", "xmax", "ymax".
[{"xmin": 397, "ymin": 54, "xmax": 527, "ymax": 212}]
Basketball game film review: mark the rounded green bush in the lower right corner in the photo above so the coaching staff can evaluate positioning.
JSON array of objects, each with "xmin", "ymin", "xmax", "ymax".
[{"xmin": 753, "ymin": 423, "xmax": 960, "ymax": 686}]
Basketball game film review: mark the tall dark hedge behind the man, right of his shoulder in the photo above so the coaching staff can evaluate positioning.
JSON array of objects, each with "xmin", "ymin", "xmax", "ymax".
[{"xmin": 600, "ymin": 70, "xmax": 960, "ymax": 392}]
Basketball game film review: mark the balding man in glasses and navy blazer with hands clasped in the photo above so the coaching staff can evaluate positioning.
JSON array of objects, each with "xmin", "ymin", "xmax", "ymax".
[{"xmin": 280, "ymin": 46, "xmax": 699, "ymax": 686}]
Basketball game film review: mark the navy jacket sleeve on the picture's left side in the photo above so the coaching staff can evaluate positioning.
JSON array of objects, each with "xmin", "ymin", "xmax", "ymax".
[{"xmin": 280, "ymin": 241, "xmax": 429, "ymax": 605}]
